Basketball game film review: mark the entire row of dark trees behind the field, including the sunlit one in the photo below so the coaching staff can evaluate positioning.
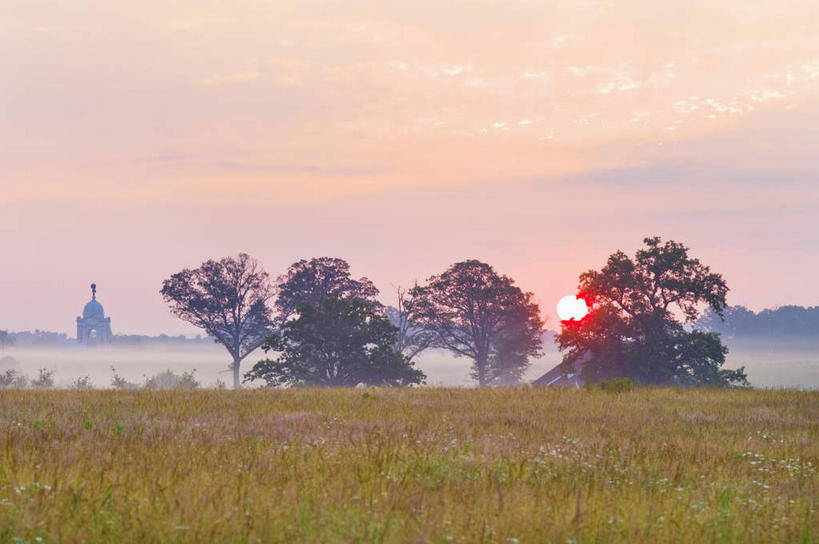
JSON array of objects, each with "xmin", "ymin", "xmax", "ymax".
[{"xmin": 161, "ymin": 237, "xmax": 747, "ymax": 388}]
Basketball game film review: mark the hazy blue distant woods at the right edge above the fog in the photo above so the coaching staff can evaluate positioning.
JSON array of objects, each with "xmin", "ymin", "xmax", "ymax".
[{"xmin": 697, "ymin": 306, "xmax": 819, "ymax": 338}]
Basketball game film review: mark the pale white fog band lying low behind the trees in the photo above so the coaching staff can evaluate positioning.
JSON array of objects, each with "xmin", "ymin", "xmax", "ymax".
[{"xmin": 0, "ymin": 338, "xmax": 819, "ymax": 389}]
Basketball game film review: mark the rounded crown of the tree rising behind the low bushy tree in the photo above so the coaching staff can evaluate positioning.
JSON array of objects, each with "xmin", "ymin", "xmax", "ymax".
[{"xmin": 276, "ymin": 257, "xmax": 378, "ymax": 324}]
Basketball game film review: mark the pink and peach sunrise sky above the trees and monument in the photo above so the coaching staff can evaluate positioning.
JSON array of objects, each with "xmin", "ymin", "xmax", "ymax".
[{"xmin": 0, "ymin": 0, "xmax": 819, "ymax": 334}]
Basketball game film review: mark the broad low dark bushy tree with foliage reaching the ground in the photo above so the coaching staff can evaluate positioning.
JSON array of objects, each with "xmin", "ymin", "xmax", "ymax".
[{"xmin": 245, "ymin": 294, "xmax": 425, "ymax": 387}]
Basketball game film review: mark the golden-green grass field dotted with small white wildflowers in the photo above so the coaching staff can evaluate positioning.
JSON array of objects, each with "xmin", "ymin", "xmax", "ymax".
[{"xmin": 0, "ymin": 388, "xmax": 819, "ymax": 543}]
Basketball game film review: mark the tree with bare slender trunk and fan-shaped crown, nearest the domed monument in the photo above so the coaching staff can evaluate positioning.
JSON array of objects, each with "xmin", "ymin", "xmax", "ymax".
[{"xmin": 161, "ymin": 253, "xmax": 273, "ymax": 389}]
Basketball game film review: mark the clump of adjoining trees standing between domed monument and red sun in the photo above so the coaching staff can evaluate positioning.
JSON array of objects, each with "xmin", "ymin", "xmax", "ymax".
[{"xmin": 161, "ymin": 253, "xmax": 543, "ymax": 388}]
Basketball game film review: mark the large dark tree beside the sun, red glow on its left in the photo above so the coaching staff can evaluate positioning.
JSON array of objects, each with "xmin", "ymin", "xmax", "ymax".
[{"xmin": 556, "ymin": 237, "xmax": 747, "ymax": 386}]
